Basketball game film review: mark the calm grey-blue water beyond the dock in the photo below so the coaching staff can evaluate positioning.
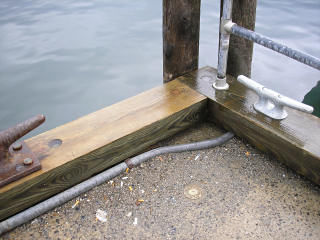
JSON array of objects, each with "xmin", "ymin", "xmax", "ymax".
[{"xmin": 0, "ymin": 0, "xmax": 320, "ymax": 138}]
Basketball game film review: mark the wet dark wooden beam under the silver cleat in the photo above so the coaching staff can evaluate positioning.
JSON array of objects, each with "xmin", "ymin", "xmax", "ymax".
[{"xmin": 178, "ymin": 67, "xmax": 320, "ymax": 185}]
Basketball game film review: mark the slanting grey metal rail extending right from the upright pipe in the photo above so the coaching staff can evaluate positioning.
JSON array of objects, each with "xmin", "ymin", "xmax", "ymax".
[{"xmin": 229, "ymin": 23, "xmax": 320, "ymax": 70}]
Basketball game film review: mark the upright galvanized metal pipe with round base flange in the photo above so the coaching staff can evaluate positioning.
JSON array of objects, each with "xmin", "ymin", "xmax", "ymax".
[{"xmin": 213, "ymin": 0, "xmax": 233, "ymax": 90}]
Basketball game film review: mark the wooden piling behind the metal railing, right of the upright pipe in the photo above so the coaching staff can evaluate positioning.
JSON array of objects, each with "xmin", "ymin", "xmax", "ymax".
[{"xmin": 220, "ymin": 0, "xmax": 257, "ymax": 77}]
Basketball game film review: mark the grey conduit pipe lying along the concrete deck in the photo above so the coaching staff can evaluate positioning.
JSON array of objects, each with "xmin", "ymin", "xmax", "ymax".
[{"xmin": 0, "ymin": 132, "xmax": 234, "ymax": 235}]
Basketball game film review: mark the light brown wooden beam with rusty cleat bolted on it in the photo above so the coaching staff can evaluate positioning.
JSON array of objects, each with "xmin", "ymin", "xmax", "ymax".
[{"xmin": 0, "ymin": 80, "xmax": 207, "ymax": 220}]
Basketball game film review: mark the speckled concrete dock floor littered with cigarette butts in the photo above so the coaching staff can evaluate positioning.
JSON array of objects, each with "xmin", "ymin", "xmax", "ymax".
[{"xmin": 2, "ymin": 123, "xmax": 320, "ymax": 239}]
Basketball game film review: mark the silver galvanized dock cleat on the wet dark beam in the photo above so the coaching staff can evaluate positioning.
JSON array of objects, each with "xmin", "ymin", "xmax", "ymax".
[{"xmin": 237, "ymin": 75, "xmax": 313, "ymax": 120}]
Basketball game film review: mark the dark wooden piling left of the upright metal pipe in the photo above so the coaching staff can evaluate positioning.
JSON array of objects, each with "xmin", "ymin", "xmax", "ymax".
[{"xmin": 162, "ymin": 0, "xmax": 201, "ymax": 82}]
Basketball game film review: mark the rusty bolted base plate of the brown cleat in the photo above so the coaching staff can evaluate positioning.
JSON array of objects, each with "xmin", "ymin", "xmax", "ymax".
[{"xmin": 0, "ymin": 141, "xmax": 41, "ymax": 187}]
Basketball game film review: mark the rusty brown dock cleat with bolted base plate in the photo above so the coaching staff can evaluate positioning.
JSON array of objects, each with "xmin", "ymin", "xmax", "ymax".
[{"xmin": 0, "ymin": 115, "xmax": 45, "ymax": 187}]
